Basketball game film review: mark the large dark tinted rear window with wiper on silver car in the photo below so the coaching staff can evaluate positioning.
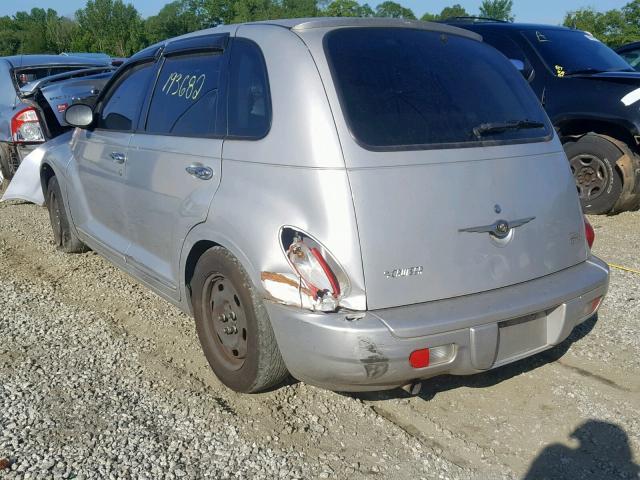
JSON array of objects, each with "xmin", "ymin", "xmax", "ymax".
[{"xmin": 325, "ymin": 28, "xmax": 551, "ymax": 150}]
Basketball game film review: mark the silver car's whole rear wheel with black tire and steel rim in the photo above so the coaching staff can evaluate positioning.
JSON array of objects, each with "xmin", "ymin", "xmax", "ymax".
[{"xmin": 191, "ymin": 247, "xmax": 288, "ymax": 393}]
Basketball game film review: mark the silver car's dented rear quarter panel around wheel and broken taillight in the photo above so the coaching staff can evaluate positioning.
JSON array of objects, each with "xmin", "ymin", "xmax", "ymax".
[{"xmin": 181, "ymin": 25, "xmax": 366, "ymax": 316}]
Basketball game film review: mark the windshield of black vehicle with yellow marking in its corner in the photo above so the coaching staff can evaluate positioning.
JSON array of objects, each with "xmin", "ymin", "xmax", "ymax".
[{"xmin": 524, "ymin": 30, "xmax": 633, "ymax": 77}]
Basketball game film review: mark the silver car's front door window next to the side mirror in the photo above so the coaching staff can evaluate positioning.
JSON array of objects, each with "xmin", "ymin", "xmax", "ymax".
[{"xmin": 97, "ymin": 62, "xmax": 153, "ymax": 131}]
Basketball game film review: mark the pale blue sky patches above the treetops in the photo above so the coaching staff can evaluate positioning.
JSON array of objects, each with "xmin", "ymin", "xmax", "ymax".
[{"xmin": 0, "ymin": 0, "xmax": 629, "ymax": 24}]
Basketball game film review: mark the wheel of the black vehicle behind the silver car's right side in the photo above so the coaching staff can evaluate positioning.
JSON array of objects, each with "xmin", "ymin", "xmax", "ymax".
[{"xmin": 564, "ymin": 133, "xmax": 623, "ymax": 215}]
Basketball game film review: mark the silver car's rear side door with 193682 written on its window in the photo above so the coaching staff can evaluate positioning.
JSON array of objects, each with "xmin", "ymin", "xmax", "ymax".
[{"xmin": 124, "ymin": 34, "xmax": 229, "ymax": 296}]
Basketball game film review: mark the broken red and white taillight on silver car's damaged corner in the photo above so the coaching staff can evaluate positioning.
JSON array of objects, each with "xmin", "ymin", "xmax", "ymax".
[{"xmin": 287, "ymin": 240, "xmax": 340, "ymax": 299}]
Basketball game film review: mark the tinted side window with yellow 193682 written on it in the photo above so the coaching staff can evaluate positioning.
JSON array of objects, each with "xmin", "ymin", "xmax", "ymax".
[{"xmin": 146, "ymin": 52, "xmax": 223, "ymax": 137}]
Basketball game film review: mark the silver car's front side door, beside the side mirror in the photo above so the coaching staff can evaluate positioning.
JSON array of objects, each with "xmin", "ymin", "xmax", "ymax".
[{"xmin": 69, "ymin": 61, "xmax": 154, "ymax": 257}]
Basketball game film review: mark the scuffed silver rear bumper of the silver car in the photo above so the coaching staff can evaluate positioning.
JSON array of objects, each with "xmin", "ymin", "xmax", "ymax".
[{"xmin": 266, "ymin": 257, "xmax": 609, "ymax": 391}]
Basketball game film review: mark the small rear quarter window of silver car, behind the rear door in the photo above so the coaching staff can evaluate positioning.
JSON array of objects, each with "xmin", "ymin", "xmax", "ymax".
[{"xmin": 228, "ymin": 38, "xmax": 271, "ymax": 139}]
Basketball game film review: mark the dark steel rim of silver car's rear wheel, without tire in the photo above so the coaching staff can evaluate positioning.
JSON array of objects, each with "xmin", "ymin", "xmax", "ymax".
[{"xmin": 205, "ymin": 273, "xmax": 248, "ymax": 370}]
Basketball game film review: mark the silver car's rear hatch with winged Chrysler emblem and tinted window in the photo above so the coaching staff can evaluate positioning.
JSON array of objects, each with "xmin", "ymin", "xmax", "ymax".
[{"xmin": 325, "ymin": 28, "xmax": 587, "ymax": 309}]
